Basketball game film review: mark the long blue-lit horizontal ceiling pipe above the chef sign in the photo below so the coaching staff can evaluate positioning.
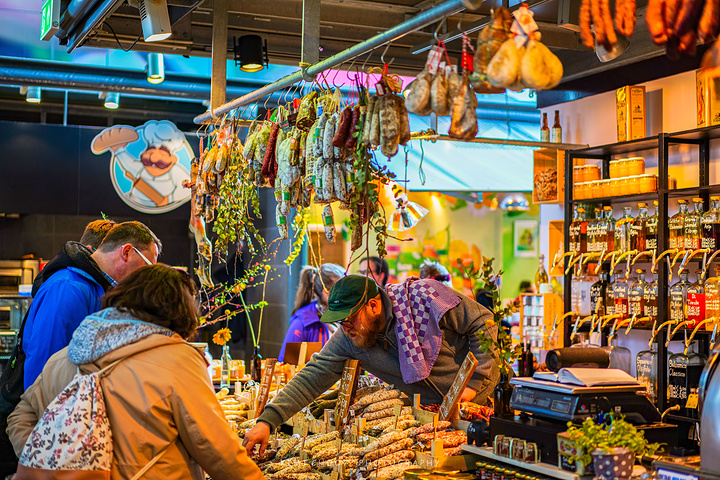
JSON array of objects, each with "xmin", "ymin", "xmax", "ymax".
[{"xmin": 0, "ymin": 56, "xmax": 293, "ymax": 106}]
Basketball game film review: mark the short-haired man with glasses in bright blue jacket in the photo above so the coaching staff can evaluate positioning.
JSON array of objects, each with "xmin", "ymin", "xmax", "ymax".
[{"xmin": 23, "ymin": 222, "xmax": 162, "ymax": 389}]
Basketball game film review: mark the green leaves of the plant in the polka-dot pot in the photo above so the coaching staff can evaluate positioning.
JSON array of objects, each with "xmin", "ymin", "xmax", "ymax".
[{"xmin": 567, "ymin": 414, "xmax": 661, "ymax": 466}]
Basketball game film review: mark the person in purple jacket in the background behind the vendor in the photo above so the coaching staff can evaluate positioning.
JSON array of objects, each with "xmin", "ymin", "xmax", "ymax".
[{"xmin": 278, "ymin": 263, "xmax": 346, "ymax": 362}]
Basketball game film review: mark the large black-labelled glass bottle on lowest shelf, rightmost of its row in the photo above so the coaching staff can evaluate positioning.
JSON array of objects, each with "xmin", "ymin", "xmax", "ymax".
[{"xmin": 668, "ymin": 342, "xmax": 707, "ymax": 417}]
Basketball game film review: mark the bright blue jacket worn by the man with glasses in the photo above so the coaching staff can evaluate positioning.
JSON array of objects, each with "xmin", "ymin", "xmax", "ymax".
[{"xmin": 23, "ymin": 267, "xmax": 105, "ymax": 389}]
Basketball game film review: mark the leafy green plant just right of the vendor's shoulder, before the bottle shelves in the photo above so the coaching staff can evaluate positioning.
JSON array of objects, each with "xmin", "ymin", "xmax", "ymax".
[{"xmin": 466, "ymin": 257, "xmax": 522, "ymax": 376}]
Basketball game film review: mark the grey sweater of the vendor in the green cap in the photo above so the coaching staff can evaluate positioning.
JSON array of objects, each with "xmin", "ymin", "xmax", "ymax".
[{"xmin": 258, "ymin": 290, "xmax": 500, "ymax": 429}]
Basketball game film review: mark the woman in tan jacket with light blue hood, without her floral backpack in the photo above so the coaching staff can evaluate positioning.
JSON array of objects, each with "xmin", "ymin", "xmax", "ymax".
[{"xmin": 7, "ymin": 264, "xmax": 264, "ymax": 480}]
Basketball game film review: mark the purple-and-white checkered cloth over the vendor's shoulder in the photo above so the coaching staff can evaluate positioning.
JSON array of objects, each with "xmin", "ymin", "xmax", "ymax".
[{"xmin": 385, "ymin": 277, "xmax": 460, "ymax": 383}]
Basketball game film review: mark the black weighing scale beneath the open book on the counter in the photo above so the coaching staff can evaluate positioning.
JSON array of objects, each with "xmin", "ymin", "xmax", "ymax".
[{"xmin": 490, "ymin": 377, "xmax": 677, "ymax": 464}]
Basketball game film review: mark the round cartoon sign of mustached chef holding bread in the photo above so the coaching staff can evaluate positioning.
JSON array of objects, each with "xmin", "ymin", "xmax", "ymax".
[{"xmin": 91, "ymin": 120, "xmax": 195, "ymax": 213}]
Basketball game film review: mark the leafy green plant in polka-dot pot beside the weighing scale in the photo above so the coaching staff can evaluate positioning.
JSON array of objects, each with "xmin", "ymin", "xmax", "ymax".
[{"xmin": 567, "ymin": 414, "xmax": 660, "ymax": 479}]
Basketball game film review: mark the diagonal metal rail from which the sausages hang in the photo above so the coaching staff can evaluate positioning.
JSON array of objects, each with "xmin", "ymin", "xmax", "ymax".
[{"xmin": 194, "ymin": 0, "xmax": 482, "ymax": 123}]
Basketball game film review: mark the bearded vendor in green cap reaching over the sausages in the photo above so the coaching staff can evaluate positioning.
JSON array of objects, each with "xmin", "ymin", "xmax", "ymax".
[{"xmin": 243, "ymin": 275, "xmax": 500, "ymax": 452}]
